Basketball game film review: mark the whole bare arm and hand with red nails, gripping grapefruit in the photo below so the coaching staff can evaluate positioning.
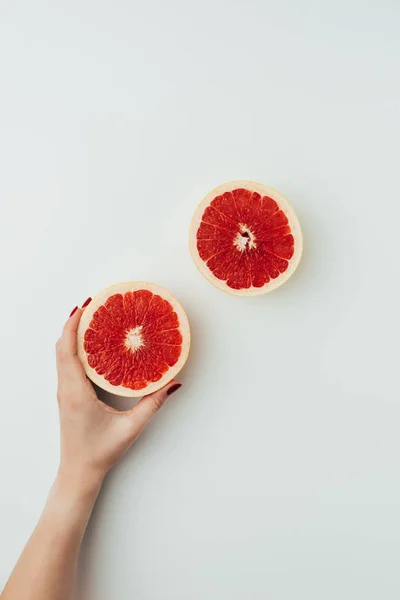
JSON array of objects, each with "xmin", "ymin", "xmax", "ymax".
[{"xmin": 1, "ymin": 299, "xmax": 180, "ymax": 600}]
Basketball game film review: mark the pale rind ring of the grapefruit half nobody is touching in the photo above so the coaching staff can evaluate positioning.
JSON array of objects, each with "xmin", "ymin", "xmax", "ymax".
[{"xmin": 189, "ymin": 181, "xmax": 303, "ymax": 296}]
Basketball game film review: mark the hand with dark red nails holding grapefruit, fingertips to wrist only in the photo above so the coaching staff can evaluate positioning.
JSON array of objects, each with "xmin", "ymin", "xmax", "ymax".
[{"xmin": 56, "ymin": 299, "xmax": 180, "ymax": 494}]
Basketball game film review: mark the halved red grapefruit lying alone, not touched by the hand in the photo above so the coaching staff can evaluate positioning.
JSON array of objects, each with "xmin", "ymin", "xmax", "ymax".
[{"xmin": 190, "ymin": 181, "xmax": 303, "ymax": 296}]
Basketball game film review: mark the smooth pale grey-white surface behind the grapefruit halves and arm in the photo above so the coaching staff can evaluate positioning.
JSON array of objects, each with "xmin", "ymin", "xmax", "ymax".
[{"xmin": 0, "ymin": 0, "xmax": 400, "ymax": 600}]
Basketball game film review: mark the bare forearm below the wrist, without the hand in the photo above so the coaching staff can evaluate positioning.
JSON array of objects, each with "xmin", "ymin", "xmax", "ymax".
[{"xmin": 1, "ymin": 473, "xmax": 101, "ymax": 600}]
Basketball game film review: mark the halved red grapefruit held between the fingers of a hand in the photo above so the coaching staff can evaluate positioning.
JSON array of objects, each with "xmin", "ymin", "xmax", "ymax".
[{"xmin": 78, "ymin": 281, "xmax": 190, "ymax": 396}]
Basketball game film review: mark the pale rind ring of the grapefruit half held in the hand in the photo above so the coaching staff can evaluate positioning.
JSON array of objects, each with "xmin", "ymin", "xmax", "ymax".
[{"xmin": 78, "ymin": 281, "xmax": 190, "ymax": 398}]
